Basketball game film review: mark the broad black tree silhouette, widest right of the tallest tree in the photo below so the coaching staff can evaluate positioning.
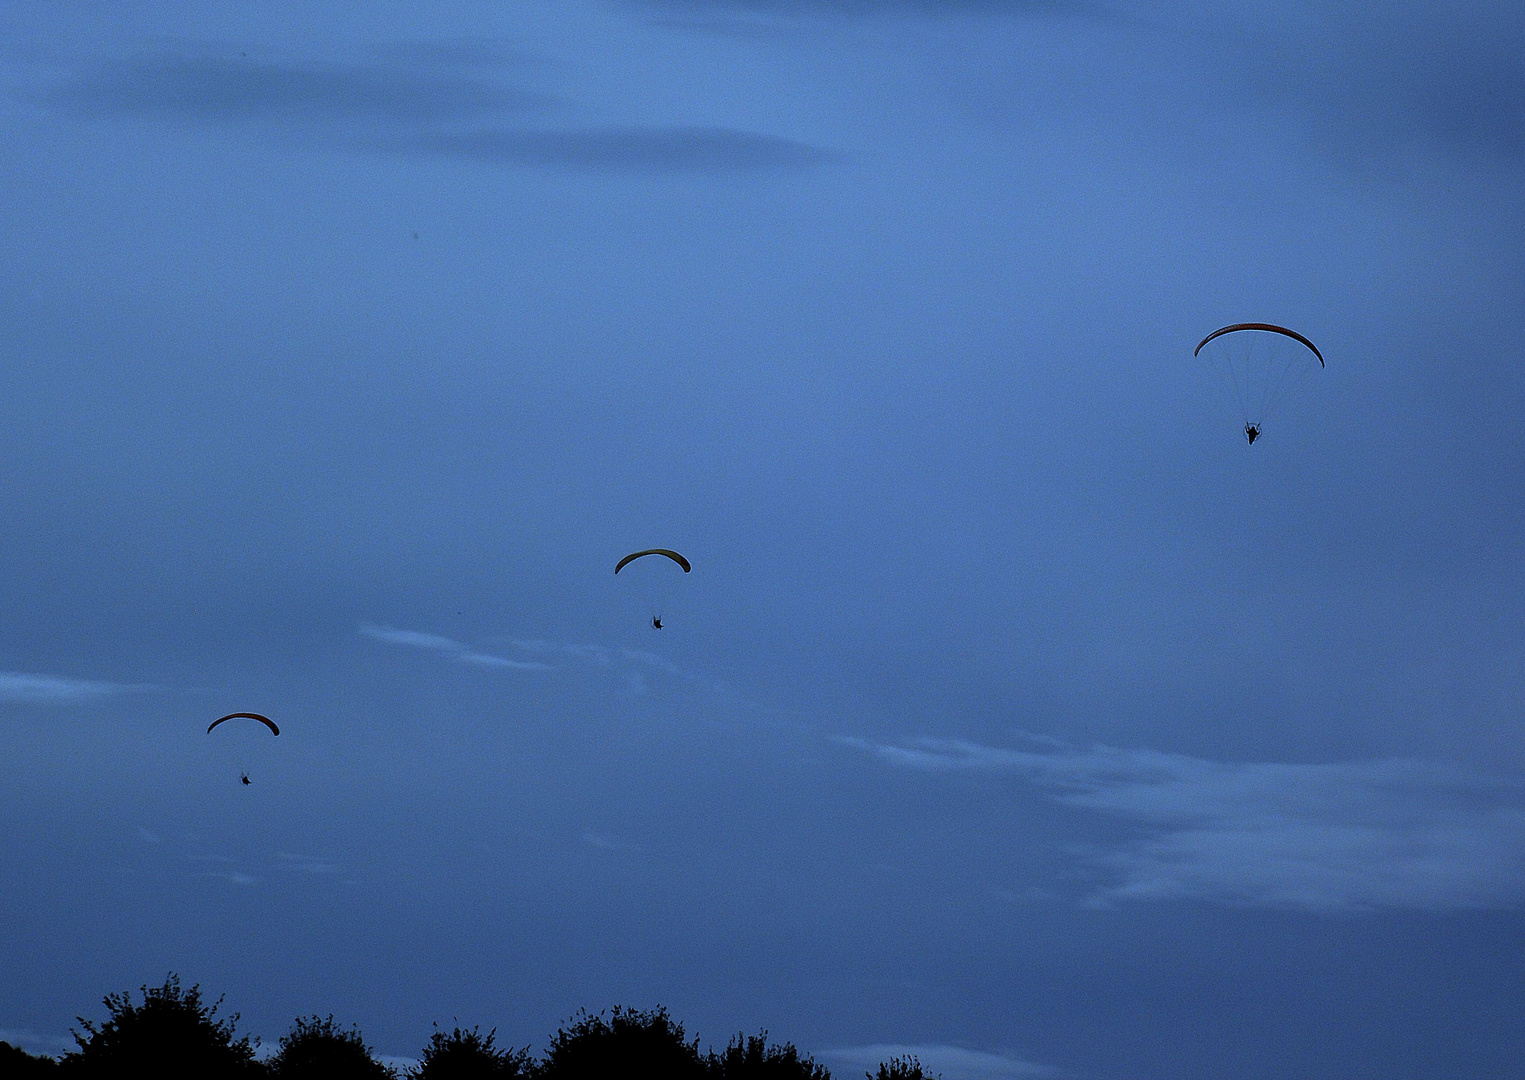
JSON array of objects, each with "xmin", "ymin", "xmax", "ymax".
[{"xmin": 537, "ymin": 1007, "xmax": 705, "ymax": 1080}]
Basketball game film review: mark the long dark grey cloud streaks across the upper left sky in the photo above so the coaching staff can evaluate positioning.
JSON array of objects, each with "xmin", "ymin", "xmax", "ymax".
[{"xmin": 52, "ymin": 48, "xmax": 836, "ymax": 172}]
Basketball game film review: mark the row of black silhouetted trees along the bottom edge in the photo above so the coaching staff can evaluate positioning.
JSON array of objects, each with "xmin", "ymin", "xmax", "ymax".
[{"xmin": 0, "ymin": 973, "xmax": 938, "ymax": 1080}]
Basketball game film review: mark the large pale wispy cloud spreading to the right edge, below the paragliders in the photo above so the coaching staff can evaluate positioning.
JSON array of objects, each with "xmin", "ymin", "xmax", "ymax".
[{"xmin": 840, "ymin": 738, "xmax": 1525, "ymax": 911}]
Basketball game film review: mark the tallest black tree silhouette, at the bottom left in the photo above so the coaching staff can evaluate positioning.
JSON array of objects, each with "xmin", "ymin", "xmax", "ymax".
[{"xmin": 63, "ymin": 975, "xmax": 262, "ymax": 1080}]
